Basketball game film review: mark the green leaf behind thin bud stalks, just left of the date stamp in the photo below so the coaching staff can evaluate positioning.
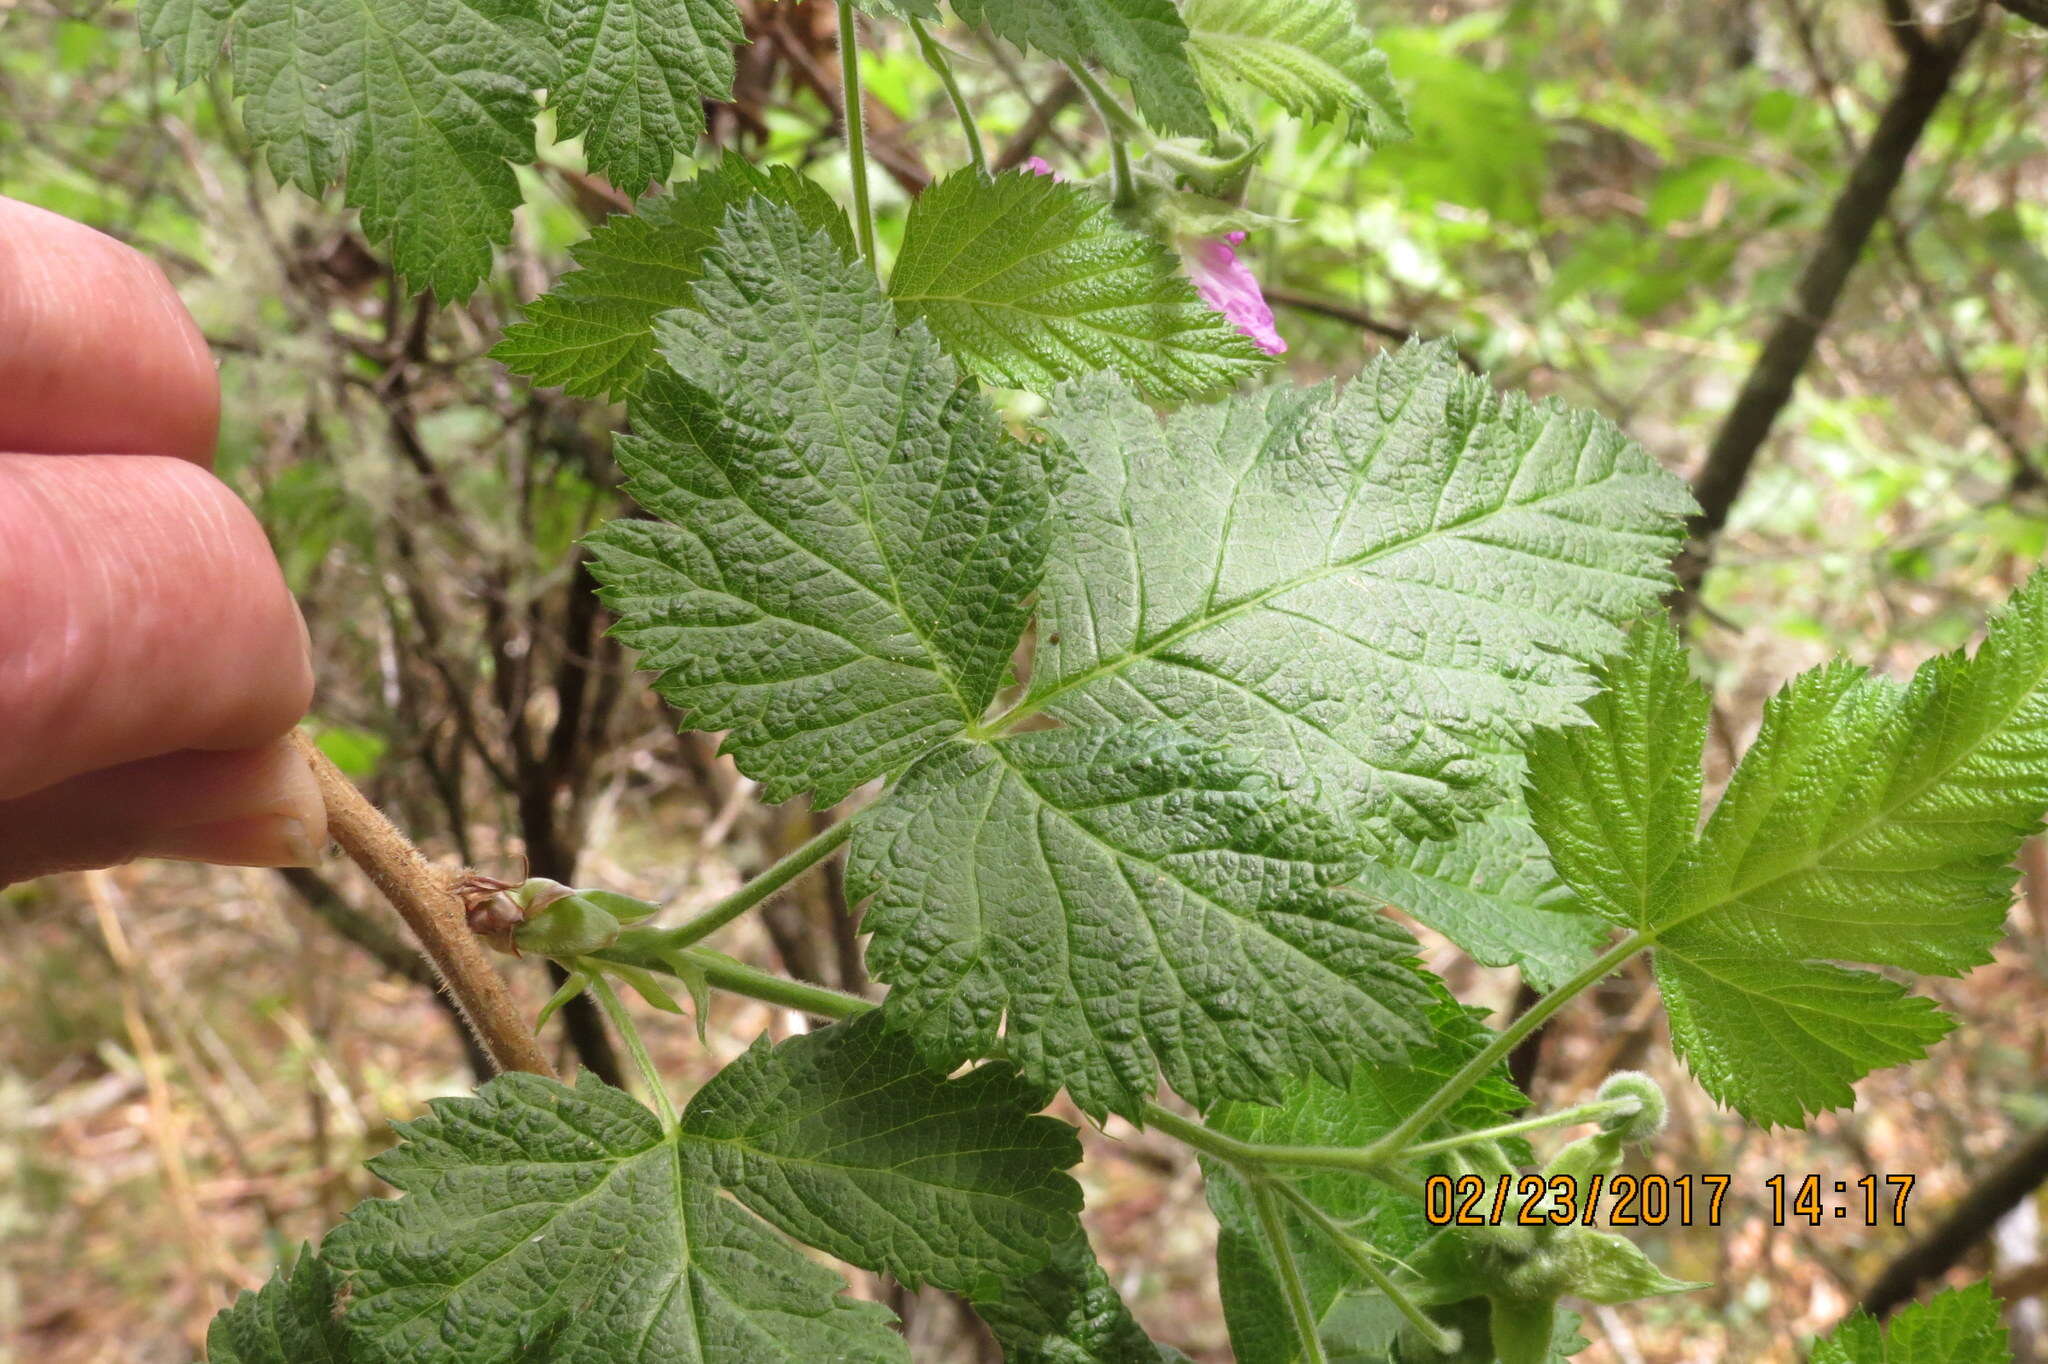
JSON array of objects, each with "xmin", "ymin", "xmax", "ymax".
[{"xmin": 1206, "ymin": 995, "xmax": 1526, "ymax": 1364}]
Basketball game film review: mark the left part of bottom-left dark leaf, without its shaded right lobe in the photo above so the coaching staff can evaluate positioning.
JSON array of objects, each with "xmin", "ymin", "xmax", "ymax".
[{"xmin": 326, "ymin": 1075, "xmax": 909, "ymax": 1364}]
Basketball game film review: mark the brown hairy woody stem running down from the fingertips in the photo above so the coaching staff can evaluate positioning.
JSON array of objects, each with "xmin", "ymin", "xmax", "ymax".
[{"xmin": 293, "ymin": 731, "xmax": 555, "ymax": 1077}]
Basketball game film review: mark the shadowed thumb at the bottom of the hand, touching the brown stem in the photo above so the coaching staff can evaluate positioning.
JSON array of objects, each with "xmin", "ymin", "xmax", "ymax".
[{"xmin": 0, "ymin": 739, "xmax": 328, "ymax": 885}]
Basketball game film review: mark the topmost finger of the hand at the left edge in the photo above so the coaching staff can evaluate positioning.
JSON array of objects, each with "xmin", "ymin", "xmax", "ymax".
[{"xmin": 0, "ymin": 197, "xmax": 221, "ymax": 467}]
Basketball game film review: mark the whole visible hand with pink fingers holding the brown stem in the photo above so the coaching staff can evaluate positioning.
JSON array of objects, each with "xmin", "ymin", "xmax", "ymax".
[{"xmin": 0, "ymin": 199, "xmax": 326, "ymax": 885}]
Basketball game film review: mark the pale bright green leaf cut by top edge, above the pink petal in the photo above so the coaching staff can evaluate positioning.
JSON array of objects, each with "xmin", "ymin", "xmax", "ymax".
[{"xmin": 1182, "ymin": 0, "xmax": 1409, "ymax": 145}]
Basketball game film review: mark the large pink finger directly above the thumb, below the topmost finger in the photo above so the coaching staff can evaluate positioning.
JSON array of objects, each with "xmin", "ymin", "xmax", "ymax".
[{"xmin": 0, "ymin": 455, "xmax": 313, "ymax": 797}]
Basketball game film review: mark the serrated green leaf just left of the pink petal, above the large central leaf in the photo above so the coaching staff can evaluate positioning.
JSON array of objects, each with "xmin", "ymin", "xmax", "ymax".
[{"xmin": 889, "ymin": 170, "xmax": 1266, "ymax": 397}]
